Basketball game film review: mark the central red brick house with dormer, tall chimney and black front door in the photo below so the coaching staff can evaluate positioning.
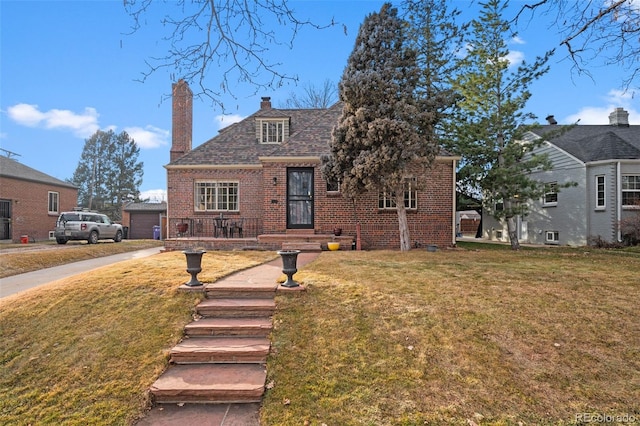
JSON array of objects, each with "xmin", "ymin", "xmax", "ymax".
[{"xmin": 165, "ymin": 80, "xmax": 458, "ymax": 249}]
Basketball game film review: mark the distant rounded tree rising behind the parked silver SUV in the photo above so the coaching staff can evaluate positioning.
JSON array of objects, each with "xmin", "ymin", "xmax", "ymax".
[{"xmin": 71, "ymin": 130, "xmax": 143, "ymax": 220}]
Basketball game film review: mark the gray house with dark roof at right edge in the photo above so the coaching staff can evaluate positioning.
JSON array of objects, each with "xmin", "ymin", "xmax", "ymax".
[{"xmin": 483, "ymin": 108, "xmax": 640, "ymax": 246}]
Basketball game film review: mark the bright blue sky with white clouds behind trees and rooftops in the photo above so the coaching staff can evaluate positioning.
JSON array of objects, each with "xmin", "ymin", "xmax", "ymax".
[{"xmin": 0, "ymin": 0, "xmax": 640, "ymax": 200}]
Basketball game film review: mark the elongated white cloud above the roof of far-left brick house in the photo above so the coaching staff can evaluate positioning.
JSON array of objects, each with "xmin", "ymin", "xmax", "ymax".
[{"xmin": 7, "ymin": 104, "xmax": 100, "ymax": 138}]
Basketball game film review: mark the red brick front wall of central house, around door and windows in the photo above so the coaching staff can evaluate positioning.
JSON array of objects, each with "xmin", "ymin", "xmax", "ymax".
[{"xmin": 168, "ymin": 160, "xmax": 455, "ymax": 249}]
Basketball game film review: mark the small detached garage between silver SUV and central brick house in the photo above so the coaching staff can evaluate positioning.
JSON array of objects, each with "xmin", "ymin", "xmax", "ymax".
[{"xmin": 122, "ymin": 202, "xmax": 167, "ymax": 240}]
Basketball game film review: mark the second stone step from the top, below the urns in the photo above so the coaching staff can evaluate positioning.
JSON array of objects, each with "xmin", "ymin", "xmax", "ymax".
[{"xmin": 196, "ymin": 298, "xmax": 276, "ymax": 318}]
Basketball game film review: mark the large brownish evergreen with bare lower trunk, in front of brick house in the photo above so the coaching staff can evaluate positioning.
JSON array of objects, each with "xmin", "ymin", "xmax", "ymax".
[{"xmin": 324, "ymin": 3, "xmax": 437, "ymax": 251}]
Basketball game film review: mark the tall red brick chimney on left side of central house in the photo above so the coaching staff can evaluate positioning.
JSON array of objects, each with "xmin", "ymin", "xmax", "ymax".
[{"xmin": 169, "ymin": 79, "xmax": 193, "ymax": 161}]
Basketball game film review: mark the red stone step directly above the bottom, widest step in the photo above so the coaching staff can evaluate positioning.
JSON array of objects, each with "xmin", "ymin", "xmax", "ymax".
[{"xmin": 171, "ymin": 337, "xmax": 271, "ymax": 364}]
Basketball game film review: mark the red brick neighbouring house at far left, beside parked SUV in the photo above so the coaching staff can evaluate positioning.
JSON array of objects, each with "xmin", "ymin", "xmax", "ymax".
[{"xmin": 0, "ymin": 155, "xmax": 78, "ymax": 242}]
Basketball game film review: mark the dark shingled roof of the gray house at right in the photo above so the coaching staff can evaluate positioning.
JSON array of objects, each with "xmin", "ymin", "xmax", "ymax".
[{"xmin": 533, "ymin": 125, "xmax": 640, "ymax": 163}]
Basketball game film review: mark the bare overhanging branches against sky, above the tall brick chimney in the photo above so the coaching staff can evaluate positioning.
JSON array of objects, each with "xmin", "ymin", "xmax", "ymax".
[{"xmin": 124, "ymin": 0, "xmax": 335, "ymax": 106}]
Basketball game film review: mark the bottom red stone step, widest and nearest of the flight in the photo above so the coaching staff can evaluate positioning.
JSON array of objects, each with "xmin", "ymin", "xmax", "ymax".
[{"xmin": 150, "ymin": 364, "xmax": 267, "ymax": 404}]
